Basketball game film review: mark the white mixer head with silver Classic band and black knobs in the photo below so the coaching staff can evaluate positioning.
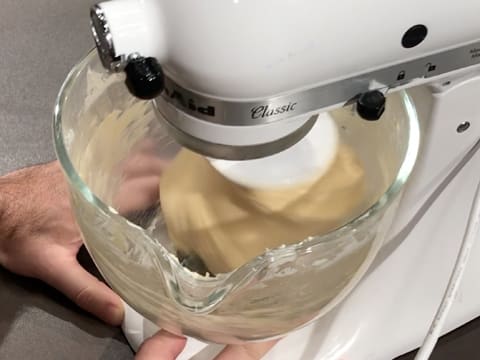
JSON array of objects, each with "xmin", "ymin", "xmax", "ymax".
[{"xmin": 91, "ymin": 0, "xmax": 480, "ymax": 165}]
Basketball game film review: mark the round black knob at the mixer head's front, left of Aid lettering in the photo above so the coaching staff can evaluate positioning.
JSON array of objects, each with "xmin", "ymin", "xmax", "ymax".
[{"xmin": 125, "ymin": 57, "xmax": 165, "ymax": 100}]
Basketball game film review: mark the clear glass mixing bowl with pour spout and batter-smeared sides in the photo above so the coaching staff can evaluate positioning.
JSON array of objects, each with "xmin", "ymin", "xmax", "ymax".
[{"xmin": 54, "ymin": 52, "xmax": 420, "ymax": 343}]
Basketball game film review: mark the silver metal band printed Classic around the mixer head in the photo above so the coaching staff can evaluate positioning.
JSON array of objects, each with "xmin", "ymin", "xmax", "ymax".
[{"xmin": 160, "ymin": 40, "xmax": 480, "ymax": 126}]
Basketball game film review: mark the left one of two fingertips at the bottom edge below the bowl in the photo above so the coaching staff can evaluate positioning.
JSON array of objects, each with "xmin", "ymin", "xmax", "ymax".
[{"xmin": 135, "ymin": 330, "xmax": 187, "ymax": 360}]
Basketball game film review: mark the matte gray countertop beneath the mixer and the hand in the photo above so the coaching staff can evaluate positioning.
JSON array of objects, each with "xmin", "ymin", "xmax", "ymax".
[{"xmin": 0, "ymin": 0, "xmax": 480, "ymax": 360}]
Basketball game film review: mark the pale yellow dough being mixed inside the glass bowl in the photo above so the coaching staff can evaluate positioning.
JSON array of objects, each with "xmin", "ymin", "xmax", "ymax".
[{"xmin": 160, "ymin": 146, "xmax": 365, "ymax": 274}]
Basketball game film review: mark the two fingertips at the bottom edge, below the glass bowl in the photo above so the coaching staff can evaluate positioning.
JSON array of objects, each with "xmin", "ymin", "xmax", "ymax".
[{"xmin": 135, "ymin": 330, "xmax": 278, "ymax": 360}]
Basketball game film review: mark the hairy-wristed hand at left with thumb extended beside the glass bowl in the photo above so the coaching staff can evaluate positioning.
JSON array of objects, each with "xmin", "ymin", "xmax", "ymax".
[{"xmin": 0, "ymin": 162, "xmax": 123, "ymax": 325}]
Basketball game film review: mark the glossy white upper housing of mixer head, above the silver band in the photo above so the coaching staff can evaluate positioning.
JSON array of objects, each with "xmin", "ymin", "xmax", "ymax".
[{"xmin": 100, "ymin": 0, "xmax": 480, "ymax": 100}]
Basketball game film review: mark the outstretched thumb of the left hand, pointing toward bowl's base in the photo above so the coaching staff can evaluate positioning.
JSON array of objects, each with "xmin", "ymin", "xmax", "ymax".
[{"xmin": 42, "ymin": 258, "xmax": 124, "ymax": 326}]
